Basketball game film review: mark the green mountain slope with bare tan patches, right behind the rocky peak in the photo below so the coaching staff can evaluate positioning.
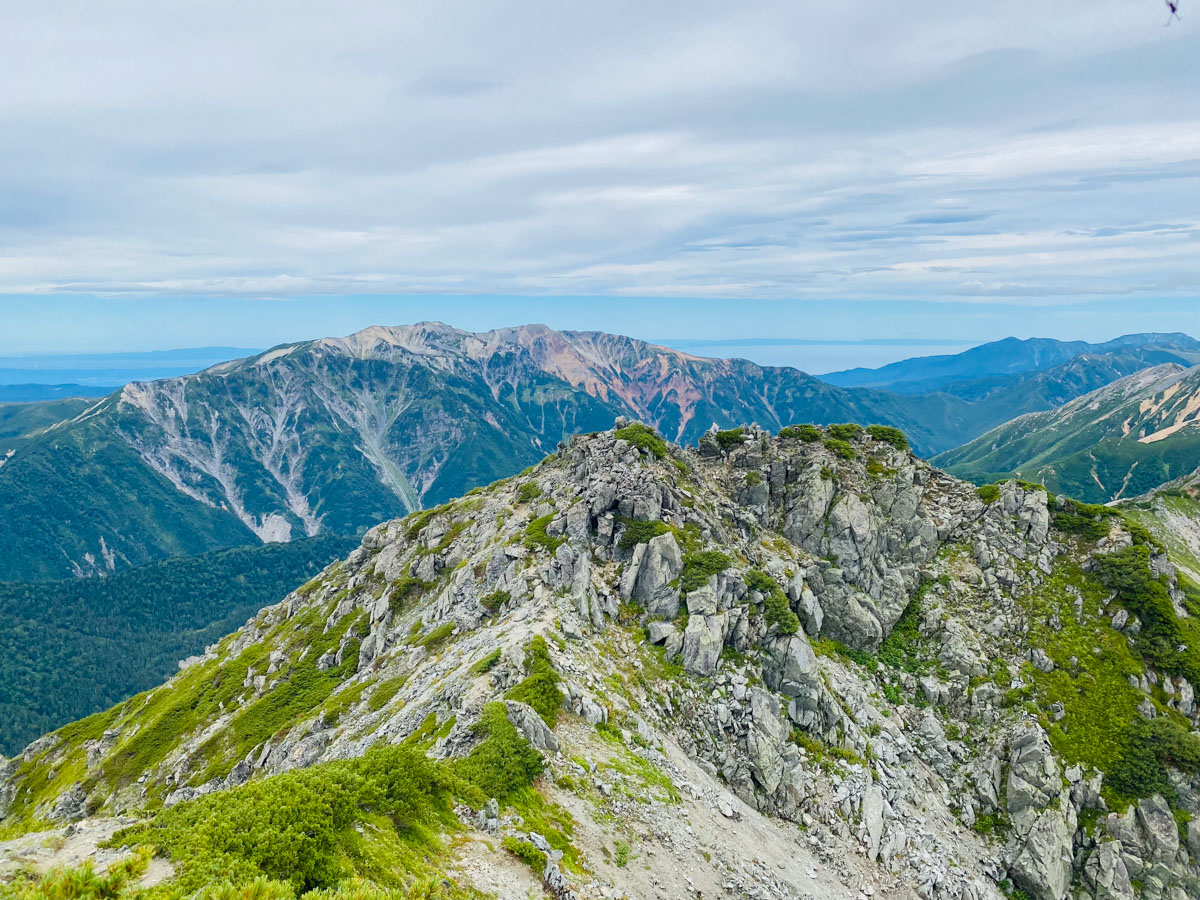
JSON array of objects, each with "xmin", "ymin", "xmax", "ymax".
[{"xmin": 934, "ymin": 364, "xmax": 1200, "ymax": 503}]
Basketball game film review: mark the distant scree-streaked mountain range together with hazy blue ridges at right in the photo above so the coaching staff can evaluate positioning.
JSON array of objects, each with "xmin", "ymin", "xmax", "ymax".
[{"xmin": 0, "ymin": 323, "xmax": 1200, "ymax": 581}]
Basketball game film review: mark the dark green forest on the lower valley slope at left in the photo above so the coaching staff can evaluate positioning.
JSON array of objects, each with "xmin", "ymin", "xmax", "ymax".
[{"xmin": 0, "ymin": 536, "xmax": 358, "ymax": 756}]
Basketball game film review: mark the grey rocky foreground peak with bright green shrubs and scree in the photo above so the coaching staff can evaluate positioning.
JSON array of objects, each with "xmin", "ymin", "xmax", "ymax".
[{"xmin": 0, "ymin": 420, "xmax": 1200, "ymax": 900}]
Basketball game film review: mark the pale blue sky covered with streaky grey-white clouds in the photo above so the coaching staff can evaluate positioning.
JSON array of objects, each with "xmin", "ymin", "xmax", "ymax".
[{"xmin": 0, "ymin": 0, "xmax": 1200, "ymax": 372}]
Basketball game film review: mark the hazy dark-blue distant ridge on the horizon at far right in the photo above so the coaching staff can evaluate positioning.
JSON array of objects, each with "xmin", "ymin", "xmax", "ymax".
[{"xmin": 821, "ymin": 332, "xmax": 1200, "ymax": 396}]
